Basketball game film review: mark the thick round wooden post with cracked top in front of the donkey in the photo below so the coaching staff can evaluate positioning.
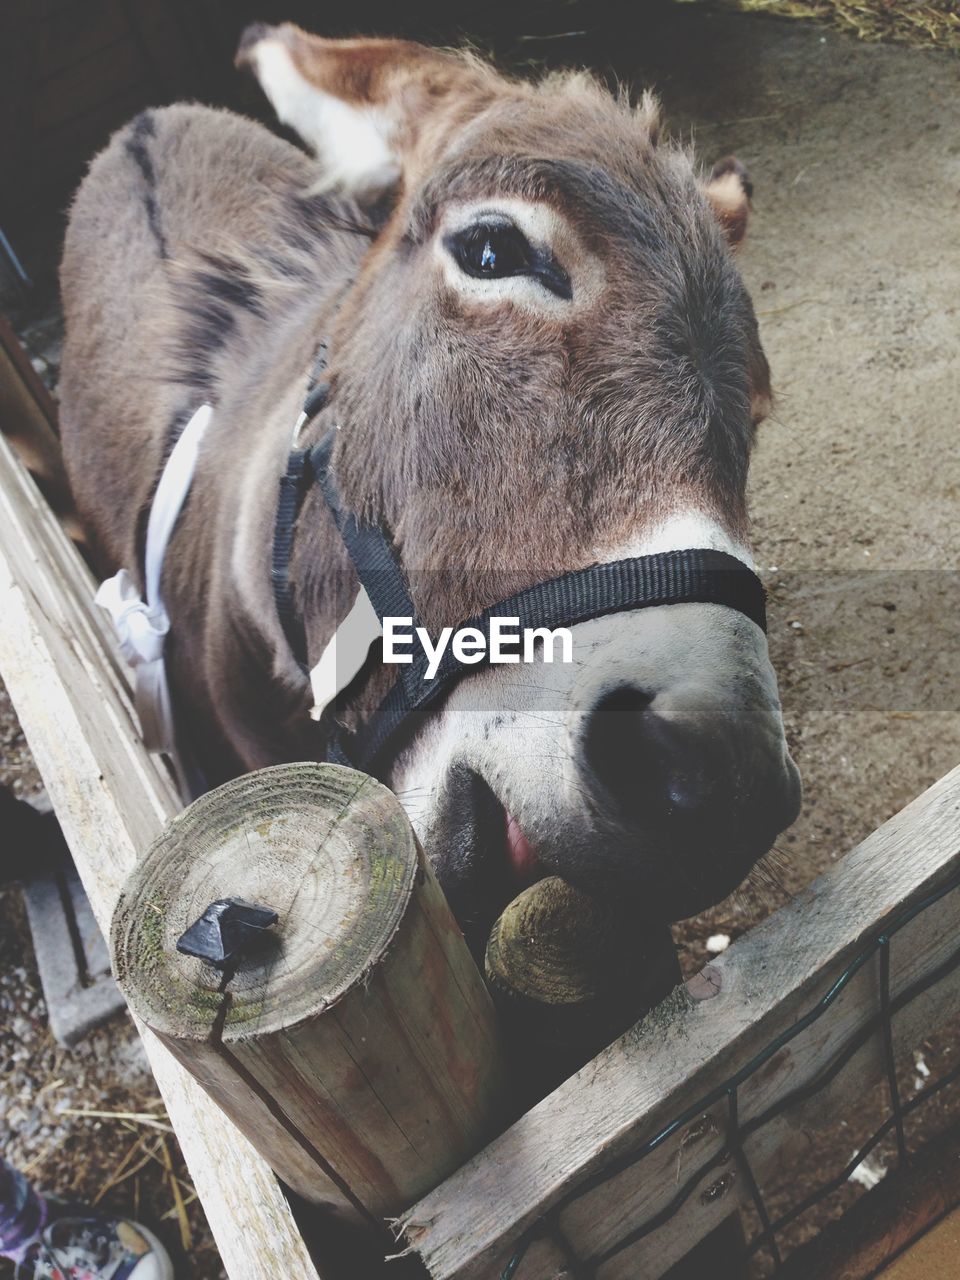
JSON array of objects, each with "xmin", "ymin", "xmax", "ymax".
[{"xmin": 113, "ymin": 764, "xmax": 512, "ymax": 1222}]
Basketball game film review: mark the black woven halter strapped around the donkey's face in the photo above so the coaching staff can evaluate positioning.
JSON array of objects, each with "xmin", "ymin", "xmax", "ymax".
[{"xmin": 273, "ymin": 383, "xmax": 767, "ymax": 773}]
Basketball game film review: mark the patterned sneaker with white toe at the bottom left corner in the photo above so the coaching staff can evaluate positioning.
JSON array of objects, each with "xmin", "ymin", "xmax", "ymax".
[{"xmin": 14, "ymin": 1211, "xmax": 173, "ymax": 1280}]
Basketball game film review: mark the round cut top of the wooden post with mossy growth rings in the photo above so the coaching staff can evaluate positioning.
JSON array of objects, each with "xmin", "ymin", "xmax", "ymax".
[{"xmin": 113, "ymin": 764, "xmax": 417, "ymax": 1041}]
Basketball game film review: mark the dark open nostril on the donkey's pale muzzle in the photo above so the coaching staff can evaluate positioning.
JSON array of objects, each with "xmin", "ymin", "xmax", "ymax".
[{"xmin": 581, "ymin": 687, "xmax": 717, "ymax": 826}]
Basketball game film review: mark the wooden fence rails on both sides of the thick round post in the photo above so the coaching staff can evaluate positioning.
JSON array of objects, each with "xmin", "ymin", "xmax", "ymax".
[{"xmin": 0, "ymin": 363, "xmax": 960, "ymax": 1280}]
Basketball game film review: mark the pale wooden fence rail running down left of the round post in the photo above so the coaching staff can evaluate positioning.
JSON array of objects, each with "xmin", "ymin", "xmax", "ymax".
[{"xmin": 0, "ymin": 424, "xmax": 325, "ymax": 1280}]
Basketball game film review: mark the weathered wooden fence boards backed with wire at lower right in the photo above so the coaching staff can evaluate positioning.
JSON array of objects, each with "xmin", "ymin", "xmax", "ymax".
[{"xmin": 403, "ymin": 768, "xmax": 960, "ymax": 1280}]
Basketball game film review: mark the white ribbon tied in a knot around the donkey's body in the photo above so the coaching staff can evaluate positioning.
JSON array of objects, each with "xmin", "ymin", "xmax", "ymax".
[{"xmin": 95, "ymin": 404, "xmax": 212, "ymax": 755}]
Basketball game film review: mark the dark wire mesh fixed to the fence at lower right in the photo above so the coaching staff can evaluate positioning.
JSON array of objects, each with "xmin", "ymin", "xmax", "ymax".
[{"xmin": 500, "ymin": 872, "xmax": 960, "ymax": 1280}]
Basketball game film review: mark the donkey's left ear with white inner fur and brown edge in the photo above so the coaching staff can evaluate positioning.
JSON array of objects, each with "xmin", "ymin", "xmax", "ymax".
[{"xmin": 237, "ymin": 23, "xmax": 483, "ymax": 200}]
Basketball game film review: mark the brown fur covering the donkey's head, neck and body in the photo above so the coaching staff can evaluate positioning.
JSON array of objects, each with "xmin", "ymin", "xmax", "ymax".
[{"xmin": 56, "ymin": 35, "xmax": 792, "ymax": 926}]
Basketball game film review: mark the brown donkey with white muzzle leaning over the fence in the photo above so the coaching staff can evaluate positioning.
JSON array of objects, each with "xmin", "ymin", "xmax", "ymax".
[{"xmin": 61, "ymin": 24, "xmax": 800, "ymax": 933}]
